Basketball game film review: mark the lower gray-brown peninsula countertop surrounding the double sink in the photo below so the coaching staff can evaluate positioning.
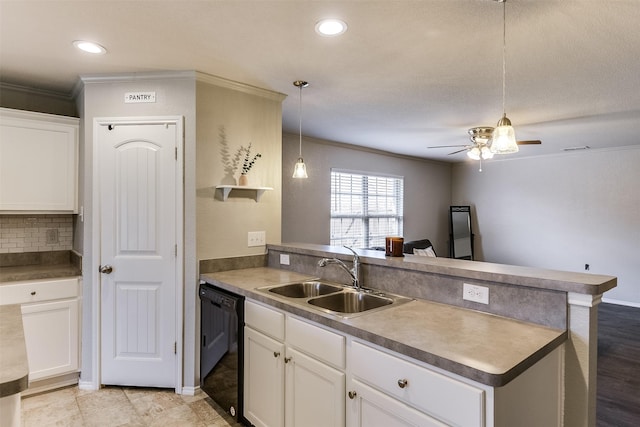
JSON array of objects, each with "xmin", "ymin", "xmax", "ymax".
[{"xmin": 200, "ymin": 268, "xmax": 567, "ymax": 387}]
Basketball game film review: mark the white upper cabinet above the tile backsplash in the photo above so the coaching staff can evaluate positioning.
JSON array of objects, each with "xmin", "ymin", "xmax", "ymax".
[{"xmin": 0, "ymin": 108, "xmax": 80, "ymax": 213}]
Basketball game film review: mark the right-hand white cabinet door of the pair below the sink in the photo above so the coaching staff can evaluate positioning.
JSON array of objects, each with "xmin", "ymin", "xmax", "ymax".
[{"xmin": 285, "ymin": 347, "xmax": 345, "ymax": 427}]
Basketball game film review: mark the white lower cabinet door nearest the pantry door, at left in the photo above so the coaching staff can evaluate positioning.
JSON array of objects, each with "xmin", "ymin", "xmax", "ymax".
[{"xmin": 22, "ymin": 298, "xmax": 79, "ymax": 381}]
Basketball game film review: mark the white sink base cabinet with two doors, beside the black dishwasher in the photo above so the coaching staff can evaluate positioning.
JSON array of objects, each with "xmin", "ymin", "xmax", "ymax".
[{"xmin": 244, "ymin": 301, "xmax": 345, "ymax": 427}]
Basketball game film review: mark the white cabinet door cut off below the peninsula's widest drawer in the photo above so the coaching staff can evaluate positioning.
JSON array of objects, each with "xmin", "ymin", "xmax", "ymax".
[{"xmin": 347, "ymin": 380, "xmax": 446, "ymax": 427}]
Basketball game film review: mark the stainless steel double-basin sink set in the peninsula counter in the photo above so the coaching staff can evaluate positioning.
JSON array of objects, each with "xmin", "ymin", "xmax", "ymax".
[{"xmin": 257, "ymin": 280, "xmax": 412, "ymax": 317}]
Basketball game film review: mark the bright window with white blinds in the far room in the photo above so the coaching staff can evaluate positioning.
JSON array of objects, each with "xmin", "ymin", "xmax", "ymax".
[{"xmin": 330, "ymin": 170, "xmax": 404, "ymax": 248}]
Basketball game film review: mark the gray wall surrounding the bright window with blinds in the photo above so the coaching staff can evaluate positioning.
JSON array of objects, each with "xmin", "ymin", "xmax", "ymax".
[{"xmin": 282, "ymin": 133, "xmax": 451, "ymax": 255}]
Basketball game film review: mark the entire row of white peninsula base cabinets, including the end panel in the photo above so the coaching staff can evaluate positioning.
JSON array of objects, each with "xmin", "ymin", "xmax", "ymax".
[{"xmin": 244, "ymin": 301, "xmax": 564, "ymax": 427}]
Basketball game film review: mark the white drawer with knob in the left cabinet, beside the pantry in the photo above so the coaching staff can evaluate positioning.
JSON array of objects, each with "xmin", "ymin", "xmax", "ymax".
[{"xmin": 0, "ymin": 278, "xmax": 79, "ymax": 305}]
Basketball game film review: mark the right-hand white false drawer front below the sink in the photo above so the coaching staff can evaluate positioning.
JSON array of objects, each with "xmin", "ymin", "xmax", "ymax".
[{"xmin": 286, "ymin": 316, "xmax": 345, "ymax": 369}]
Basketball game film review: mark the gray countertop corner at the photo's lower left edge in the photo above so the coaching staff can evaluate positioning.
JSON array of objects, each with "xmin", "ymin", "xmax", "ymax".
[{"xmin": 0, "ymin": 304, "xmax": 29, "ymax": 398}]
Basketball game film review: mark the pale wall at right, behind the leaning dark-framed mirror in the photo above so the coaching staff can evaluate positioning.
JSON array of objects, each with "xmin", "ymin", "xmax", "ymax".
[{"xmin": 452, "ymin": 146, "xmax": 640, "ymax": 306}]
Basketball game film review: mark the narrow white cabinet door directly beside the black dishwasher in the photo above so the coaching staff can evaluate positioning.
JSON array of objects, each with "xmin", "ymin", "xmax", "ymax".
[{"xmin": 244, "ymin": 327, "xmax": 284, "ymax": 427}]
